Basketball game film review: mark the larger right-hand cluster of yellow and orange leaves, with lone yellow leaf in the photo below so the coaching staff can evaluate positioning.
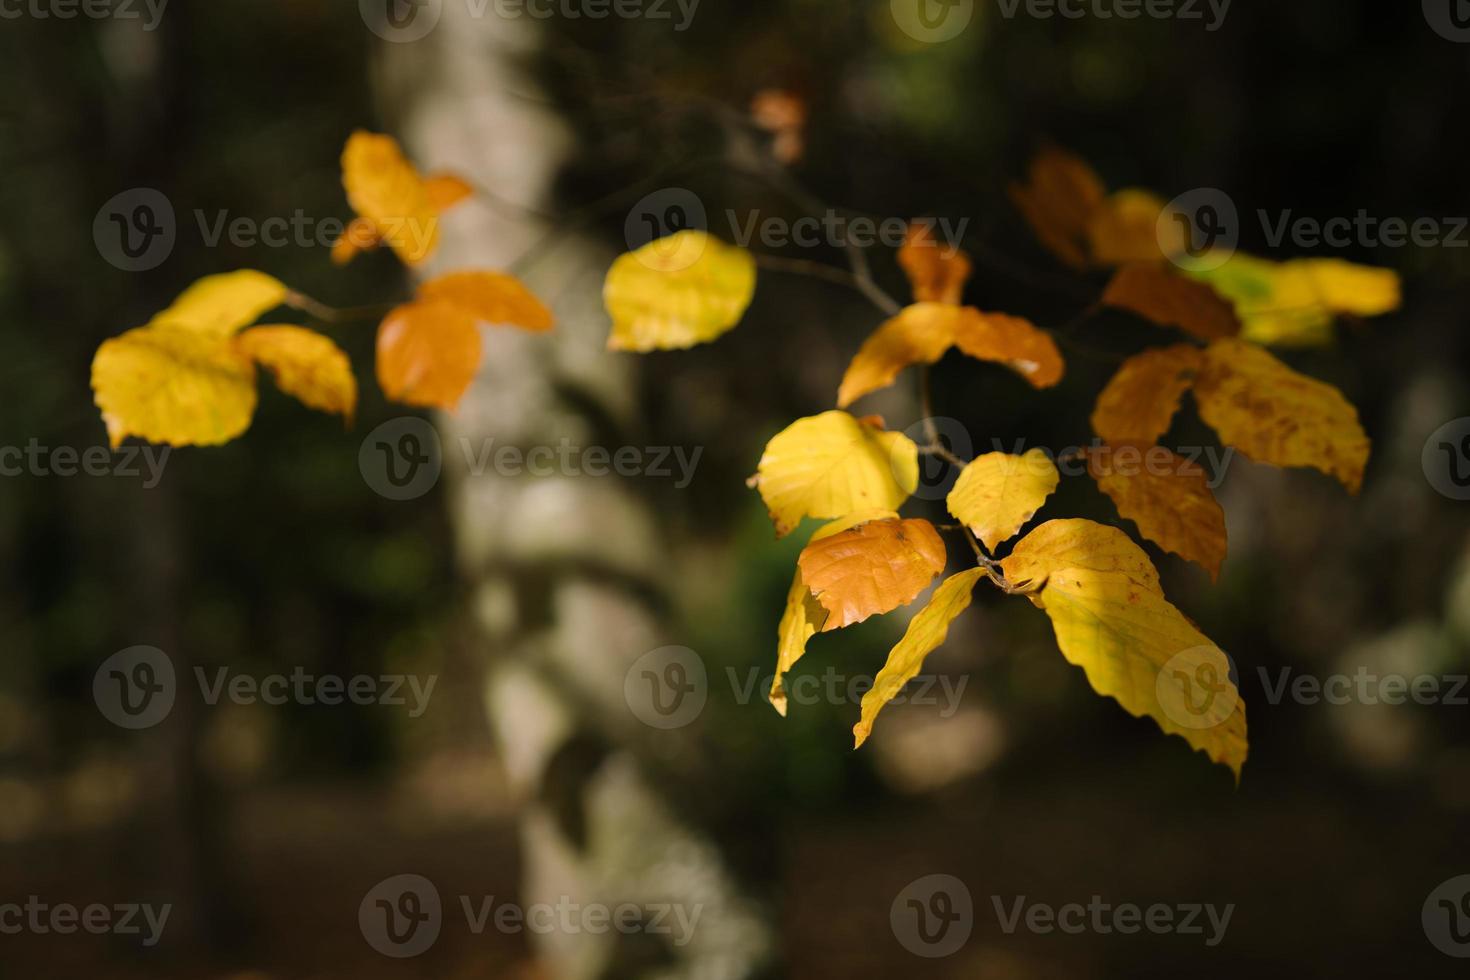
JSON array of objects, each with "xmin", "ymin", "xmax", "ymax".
[{"xmin": 604, "ymin": 150, "xmax": 1398, "ymax": 779}]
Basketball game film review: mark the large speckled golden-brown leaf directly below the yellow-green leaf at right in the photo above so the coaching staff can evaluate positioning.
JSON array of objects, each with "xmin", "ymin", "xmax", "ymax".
[{"xmin": 1195, "ymin": 339, "xmax": 1370, "ymax": 494}]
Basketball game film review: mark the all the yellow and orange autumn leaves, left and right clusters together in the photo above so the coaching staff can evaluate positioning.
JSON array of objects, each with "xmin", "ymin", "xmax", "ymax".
[{"xmin": 93, "ymin": 128, "xmax": 1398, "ymax": 779}]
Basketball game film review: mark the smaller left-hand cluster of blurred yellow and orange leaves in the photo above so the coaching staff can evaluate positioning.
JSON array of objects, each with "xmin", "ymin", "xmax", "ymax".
[{"xmin": 91, "ymin": 132, "xmax": 551, "ymax": 445}]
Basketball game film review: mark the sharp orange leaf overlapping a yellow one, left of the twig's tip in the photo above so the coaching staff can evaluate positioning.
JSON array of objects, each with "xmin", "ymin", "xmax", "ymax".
[{"xmin": 797, "ymin": 517, "xmax": 945, "ymax": 632}]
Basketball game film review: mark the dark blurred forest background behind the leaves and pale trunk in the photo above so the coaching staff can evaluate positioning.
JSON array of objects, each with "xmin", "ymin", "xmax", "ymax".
[{"xmin": 0, "ymin": 0, "xmax": 1470, "ymax": 980}]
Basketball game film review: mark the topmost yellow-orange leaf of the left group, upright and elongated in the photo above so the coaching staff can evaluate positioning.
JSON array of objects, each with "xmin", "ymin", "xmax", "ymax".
[{"xmin": 343, "ymin": 129, "xmax": 440, "ymax": 266}]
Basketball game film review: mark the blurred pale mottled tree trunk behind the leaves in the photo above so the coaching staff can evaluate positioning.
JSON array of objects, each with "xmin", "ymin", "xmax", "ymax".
[{"xmin": 378, "ymin": 3, "xmax": 775, "ymax": 980}]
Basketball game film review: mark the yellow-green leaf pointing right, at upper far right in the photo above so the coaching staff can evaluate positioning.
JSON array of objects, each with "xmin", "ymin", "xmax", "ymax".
[{"xmin": 1180, "ymin": 251, "xmax": 1401, "ymax": 347}]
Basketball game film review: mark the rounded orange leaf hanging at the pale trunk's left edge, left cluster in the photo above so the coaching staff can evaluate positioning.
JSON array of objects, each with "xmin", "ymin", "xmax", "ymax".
[{"xmin": 378, "ymin": 300, "xmax": 481, "ymax": 408}]
